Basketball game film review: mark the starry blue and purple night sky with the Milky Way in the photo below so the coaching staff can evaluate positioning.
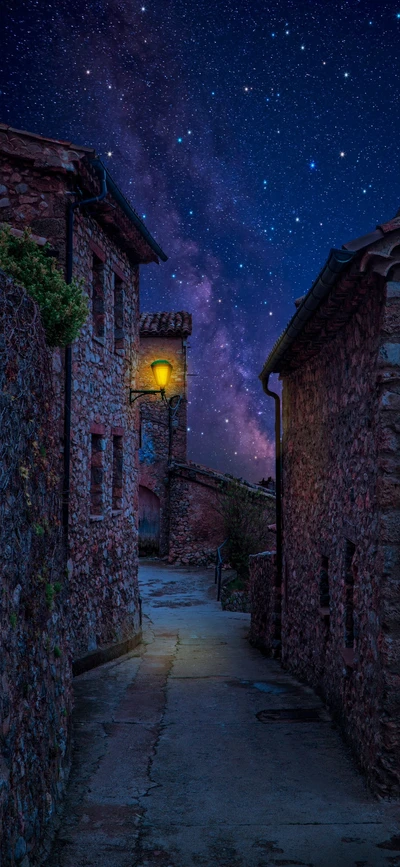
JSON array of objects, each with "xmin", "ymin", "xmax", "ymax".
[{"xmin": 0, "ymin": 0, "xmax": 400, "ymax": 481}]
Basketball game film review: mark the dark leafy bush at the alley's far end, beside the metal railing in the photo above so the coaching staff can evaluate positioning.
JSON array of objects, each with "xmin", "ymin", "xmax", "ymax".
[{"xmin": 219, "ymin": 482, "xmax": 273, "ymax": 581}]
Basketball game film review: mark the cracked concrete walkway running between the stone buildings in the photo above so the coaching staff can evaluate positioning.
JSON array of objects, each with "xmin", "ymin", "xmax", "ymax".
[{"xmin": 47, "ymin": 562, "xmax": 400, "ymax": 867}]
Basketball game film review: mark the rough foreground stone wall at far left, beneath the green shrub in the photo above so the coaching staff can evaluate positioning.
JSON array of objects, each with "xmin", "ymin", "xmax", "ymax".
[{"xmin": 0, "ymin": 271, "xmax": 72, "ymax": 867}]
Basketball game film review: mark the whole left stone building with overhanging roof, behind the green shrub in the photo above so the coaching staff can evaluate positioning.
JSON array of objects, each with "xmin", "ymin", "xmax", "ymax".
[{"xmin": 0, "ymin": 124, "xmax": 166, "ymax": 671}]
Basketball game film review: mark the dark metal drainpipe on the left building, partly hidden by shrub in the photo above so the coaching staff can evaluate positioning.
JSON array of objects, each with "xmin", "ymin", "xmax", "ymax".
[{"xmin": 62, "ymin": 170, "xmax": 107, "ymax": 547}]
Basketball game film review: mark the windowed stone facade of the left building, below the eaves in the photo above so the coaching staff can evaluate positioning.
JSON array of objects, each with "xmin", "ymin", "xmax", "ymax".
[{"xmin": 68, "ymin": 215, "xmax": 140, "ymax": 659}]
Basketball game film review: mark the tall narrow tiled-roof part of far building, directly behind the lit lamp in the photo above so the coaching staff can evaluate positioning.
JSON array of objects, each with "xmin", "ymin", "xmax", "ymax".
[{"xmin": 137, "ymin": 311, "xmax": 192, "ymax": 556}]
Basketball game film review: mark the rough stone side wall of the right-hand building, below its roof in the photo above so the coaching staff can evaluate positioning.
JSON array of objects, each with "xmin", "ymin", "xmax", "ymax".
[{"xmin": 282, "ymin": 278, "xmax": 400, "ymax": 794}]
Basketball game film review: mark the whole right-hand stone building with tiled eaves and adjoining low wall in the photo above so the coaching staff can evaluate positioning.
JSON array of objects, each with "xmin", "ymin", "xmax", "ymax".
[{"xmin": 252, "ymin": 216, "xmax": 400, "ymax": 795}]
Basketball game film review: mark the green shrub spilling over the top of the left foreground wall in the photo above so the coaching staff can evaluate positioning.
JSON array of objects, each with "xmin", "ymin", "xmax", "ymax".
[{"xmin": 0, "ymin": 226, "xmax": 88, "ymax": 346}]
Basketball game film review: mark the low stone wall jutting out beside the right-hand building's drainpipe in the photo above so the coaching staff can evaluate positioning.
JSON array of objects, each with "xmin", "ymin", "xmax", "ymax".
[{"xmin": 249, "ymin": 551, "xmax": 281, "ymax": 657}]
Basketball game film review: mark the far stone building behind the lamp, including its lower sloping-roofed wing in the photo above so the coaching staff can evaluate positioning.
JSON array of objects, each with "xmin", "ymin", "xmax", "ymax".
[{"xmin": 137, "ymin": 311, "xmax": 273, "ymax": 566}]
